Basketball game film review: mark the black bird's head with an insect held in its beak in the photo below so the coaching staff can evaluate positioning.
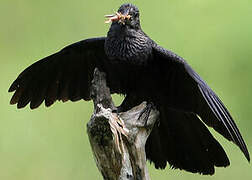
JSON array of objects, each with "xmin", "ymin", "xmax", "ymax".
[{"xmin": 105, "ymin": 4, "xmax": 140, "ymax": 29}]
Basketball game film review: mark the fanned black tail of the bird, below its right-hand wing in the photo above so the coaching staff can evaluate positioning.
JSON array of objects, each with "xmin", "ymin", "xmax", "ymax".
[{"xmin": 145, "ymin": 108, "xmax": 230, "ymax": 175}]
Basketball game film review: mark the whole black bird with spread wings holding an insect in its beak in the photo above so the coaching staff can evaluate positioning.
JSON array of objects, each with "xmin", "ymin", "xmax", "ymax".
[{"xmin": 9, "ymin": 4, "xmax": 250, "ymax": 174}]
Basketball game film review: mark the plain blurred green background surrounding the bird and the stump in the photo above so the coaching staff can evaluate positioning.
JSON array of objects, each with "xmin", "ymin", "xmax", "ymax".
[{"xmin": 0, "ymin": 0, "xmax": 252, "ymax": 180}]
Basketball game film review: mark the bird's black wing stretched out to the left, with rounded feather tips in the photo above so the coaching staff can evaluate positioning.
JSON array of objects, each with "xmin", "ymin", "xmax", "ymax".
[{"xmin": 9, "ymin": 38, "xmax": 106, "ymax": 109}]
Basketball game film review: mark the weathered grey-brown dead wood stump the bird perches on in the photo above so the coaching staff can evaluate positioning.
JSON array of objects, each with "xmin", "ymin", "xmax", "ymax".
[{"xmin": 87, "ymin": 69, "xmax": 158, "ymax": 180}]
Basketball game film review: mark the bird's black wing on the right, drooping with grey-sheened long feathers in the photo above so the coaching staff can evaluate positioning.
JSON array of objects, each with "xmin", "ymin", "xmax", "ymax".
[{"xmin": 153, "ymin": 45, "xmax": 250, "ymax": 161}]
